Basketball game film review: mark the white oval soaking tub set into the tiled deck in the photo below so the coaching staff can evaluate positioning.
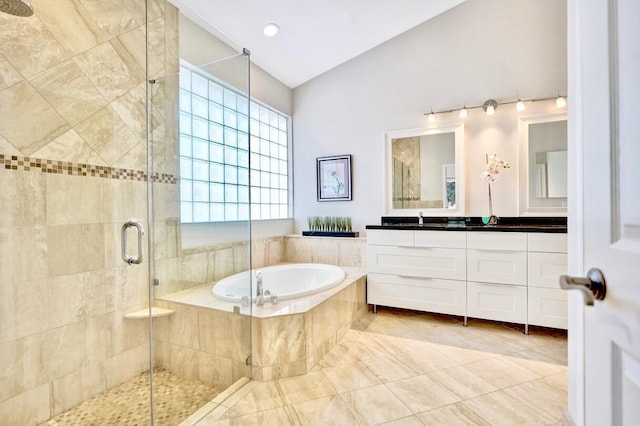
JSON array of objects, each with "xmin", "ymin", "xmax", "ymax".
[{"xmin": 211, "ymin": 263, "xmax": 345, "ymax": 303}]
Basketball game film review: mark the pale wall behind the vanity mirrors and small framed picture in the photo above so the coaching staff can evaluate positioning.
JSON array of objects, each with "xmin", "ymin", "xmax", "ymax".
[{"xmin": 293, "ymin": 0, "xmax": 567, "ymax": 231}]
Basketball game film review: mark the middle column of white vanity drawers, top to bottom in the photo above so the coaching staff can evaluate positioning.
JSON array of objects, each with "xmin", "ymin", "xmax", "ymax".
[{"xmin": 467, "ymin": 232, "xmax": 527, "ymax": 324}]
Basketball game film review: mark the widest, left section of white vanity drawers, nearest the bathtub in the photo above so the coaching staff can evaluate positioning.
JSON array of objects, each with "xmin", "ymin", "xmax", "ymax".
[{"xmin": 367, "ymin": 230, "xmax": 466, "ymax": 316}]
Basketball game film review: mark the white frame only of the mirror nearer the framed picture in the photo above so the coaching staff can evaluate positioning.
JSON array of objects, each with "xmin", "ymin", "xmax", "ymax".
[{"xmin": 384, "ymin": 124, "xmax": 466, "ymax": 217}]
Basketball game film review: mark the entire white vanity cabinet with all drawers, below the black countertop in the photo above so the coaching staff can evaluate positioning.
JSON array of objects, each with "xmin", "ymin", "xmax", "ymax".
[{"xmin": 367, "ymin": 229, "xmax": 567, "ymax": 331}]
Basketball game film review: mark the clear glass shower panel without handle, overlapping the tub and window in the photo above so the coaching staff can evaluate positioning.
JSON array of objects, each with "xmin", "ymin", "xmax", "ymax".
[{"xmin": 148, "ymin": 4, "xmax": 251, "ymax": 420}]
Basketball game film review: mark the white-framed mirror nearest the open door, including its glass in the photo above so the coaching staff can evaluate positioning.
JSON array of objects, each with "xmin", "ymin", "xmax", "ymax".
[{"xmin": 519, "ymin": 113, "xmax": 568, "ymax": 216}]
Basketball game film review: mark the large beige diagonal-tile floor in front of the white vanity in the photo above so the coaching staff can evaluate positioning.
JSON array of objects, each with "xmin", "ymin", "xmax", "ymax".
[{"xmin": 197, "ymin": 309, "xmax": 567, "ymax": 426}]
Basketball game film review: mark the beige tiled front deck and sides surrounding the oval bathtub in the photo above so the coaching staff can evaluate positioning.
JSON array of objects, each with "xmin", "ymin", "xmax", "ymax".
[{"xmin": 154, "ymin": 267, "xmax": 367, "ymax": 386}]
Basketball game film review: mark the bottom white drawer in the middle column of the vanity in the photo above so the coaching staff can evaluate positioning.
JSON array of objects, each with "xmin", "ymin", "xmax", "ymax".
[{"xmin": 467, "ymin": 281, "xmax": 527, "ymax": 324}]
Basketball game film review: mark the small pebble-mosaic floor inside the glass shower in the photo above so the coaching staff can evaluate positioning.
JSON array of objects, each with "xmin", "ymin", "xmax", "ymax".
[{"xmin": 42, "ymin": 369, "xmax": 222, "ymax": 426}]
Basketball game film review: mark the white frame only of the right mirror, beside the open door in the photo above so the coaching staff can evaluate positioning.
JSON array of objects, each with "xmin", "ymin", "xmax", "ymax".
[{"xmin": 518, "ymin": 112, "xmax": 568, "ymax": 216}]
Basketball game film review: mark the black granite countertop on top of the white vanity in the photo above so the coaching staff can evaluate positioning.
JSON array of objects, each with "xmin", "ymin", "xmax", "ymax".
[{"xmin": 365, "ymin": 216, "xmax": 567, "ymax": 233}]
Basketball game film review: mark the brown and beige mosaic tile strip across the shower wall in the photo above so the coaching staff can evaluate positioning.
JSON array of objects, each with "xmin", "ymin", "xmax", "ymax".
[{"xmin": 0, "ymin": 154, "xmax": 180, "ymax": 185}]
